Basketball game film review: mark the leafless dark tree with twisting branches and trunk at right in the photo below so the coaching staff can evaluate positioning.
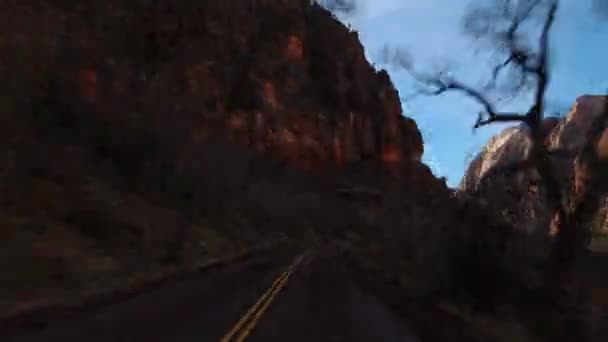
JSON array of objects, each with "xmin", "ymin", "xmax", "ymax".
[{"xmin": 384, "ymin": 0, "xmax": 605, "ymax": 286}]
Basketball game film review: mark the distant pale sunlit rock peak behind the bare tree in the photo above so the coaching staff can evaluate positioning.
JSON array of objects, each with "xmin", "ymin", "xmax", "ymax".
[{"xmin": 460, "ymin": 95, "xmax": 608, "ymax": 235}]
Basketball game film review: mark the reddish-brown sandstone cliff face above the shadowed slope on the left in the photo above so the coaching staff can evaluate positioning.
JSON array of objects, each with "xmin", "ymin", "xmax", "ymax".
[{"xmin": 0, "ymin": 0, "xmax": 423, "ymax": 184}]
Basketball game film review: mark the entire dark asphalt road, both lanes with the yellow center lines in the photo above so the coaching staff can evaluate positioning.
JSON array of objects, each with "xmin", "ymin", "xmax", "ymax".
[{"xmin": 0, "ymin": 247, "xmax": 418, "ymax": 342}]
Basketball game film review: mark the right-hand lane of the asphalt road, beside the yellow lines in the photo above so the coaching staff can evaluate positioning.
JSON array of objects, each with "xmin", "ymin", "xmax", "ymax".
[{"xmin": 247, "ymin": 248, "xmax": 419, "ymax": 342}]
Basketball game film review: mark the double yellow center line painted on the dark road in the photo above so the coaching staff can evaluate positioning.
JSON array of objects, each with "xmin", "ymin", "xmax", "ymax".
[{"xmin": 220, "ymin": 253, "xmax": 307, "ymax": 342}]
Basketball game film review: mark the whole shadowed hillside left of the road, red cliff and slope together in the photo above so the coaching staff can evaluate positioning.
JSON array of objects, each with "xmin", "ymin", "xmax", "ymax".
[{"xmin": 0, "ymin": 0, "xmax": 447, "ymax": 316}]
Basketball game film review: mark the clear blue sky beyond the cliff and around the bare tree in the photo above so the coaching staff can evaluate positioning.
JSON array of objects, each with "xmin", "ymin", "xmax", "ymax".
[{"xmin": 330, "ymin": 0, "xmax": 608, "ymax": 186}]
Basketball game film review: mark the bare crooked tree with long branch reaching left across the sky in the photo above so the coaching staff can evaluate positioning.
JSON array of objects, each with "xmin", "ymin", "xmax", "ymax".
[{"xmin": 394, "ymin": 0, "xmax": 597, "ymax": 287}]
